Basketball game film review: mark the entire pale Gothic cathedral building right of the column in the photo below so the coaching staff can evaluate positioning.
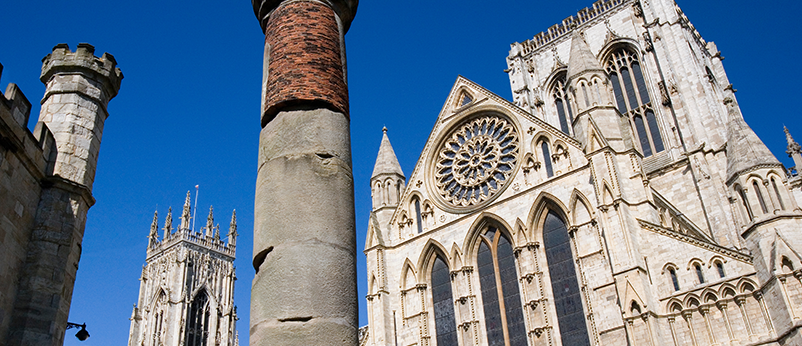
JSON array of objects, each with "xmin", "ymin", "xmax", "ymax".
[{"xmin": 361, "ymin": 0, "xmax": 802, "ymax": 346}]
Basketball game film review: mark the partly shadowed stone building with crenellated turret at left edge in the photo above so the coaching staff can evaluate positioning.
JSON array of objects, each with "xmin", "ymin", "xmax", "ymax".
[{"xmin": 0, "ymin": 43, "xmax": 123, "ymax": 345}]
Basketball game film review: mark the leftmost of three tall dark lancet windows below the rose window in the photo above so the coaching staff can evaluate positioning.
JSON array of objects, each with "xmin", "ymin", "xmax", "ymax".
[{"xmin": 432, "ymin": 256, "xmax": 457, "ymax": 346}]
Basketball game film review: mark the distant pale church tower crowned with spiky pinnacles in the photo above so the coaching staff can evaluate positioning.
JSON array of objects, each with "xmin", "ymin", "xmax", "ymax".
[{"xmin": 128, "ymin": 192, "xmax": 239, "ymax": 346}]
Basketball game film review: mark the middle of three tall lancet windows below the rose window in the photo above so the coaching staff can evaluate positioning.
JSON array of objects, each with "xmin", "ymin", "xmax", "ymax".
[{"xmin": 476, "ymin": 226, "xmax": 527, "ymax": 346}]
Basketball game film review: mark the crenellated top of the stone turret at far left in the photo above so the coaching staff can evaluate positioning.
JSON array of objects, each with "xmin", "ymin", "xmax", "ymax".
[{"xmin": 39, "ymin": 43, "xmax": 123, "ymax": 100}]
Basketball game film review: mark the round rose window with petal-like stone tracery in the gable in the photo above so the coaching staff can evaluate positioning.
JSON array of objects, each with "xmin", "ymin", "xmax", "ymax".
[{"xmin": 434, "ymin": 115, "xmax": 518, "ymax": 207}]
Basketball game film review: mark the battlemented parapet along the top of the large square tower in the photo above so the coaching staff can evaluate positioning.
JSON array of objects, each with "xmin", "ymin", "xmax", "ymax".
[{"xmin": 510, "ymin": 0, "xmax": 632, "ymax": 56}]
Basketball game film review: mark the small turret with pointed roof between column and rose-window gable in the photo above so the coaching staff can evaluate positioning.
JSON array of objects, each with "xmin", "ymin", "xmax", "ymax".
[{"xmin": 370, "ymin": 127, "xmax": 406, "ymax": 210}]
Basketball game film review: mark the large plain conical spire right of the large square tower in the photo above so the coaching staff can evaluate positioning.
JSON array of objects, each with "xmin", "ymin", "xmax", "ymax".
[{"xmin": 724, "ymin": 92, "xmax": 780, "ymax": 182}]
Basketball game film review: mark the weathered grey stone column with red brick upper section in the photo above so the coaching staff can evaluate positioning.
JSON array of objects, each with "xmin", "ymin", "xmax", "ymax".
[{"xmin": 250, "ymin": 0, "xmax": 358, "ymax": 346}]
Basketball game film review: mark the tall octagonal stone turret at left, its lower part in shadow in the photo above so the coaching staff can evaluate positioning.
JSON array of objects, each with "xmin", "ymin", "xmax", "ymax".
[{"xmin": 8, "ymin": 43, "xmax": 123, "ymax": 346}]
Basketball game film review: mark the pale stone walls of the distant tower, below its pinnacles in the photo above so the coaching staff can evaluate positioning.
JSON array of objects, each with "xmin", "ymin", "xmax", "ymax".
[{"xmin": 128, "ymin": 222, "xmax": 238, "ymax": 346}]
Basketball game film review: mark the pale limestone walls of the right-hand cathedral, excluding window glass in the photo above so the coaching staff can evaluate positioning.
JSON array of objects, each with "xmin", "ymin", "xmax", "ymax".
[{"xmin": 365, "ymin": 0, "xmax": 802, "ymax": 346}]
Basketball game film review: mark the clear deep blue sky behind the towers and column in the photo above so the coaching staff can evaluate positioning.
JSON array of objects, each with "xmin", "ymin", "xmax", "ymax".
[{"xmin": 0, "ymin": 0, "xmax": 802, "ymax": 345}]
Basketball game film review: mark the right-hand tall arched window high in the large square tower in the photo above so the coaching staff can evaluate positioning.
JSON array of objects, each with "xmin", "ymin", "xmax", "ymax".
[{"xmin": 606, "ymin": 49, "xmax": 665, "ymax": 157}]
